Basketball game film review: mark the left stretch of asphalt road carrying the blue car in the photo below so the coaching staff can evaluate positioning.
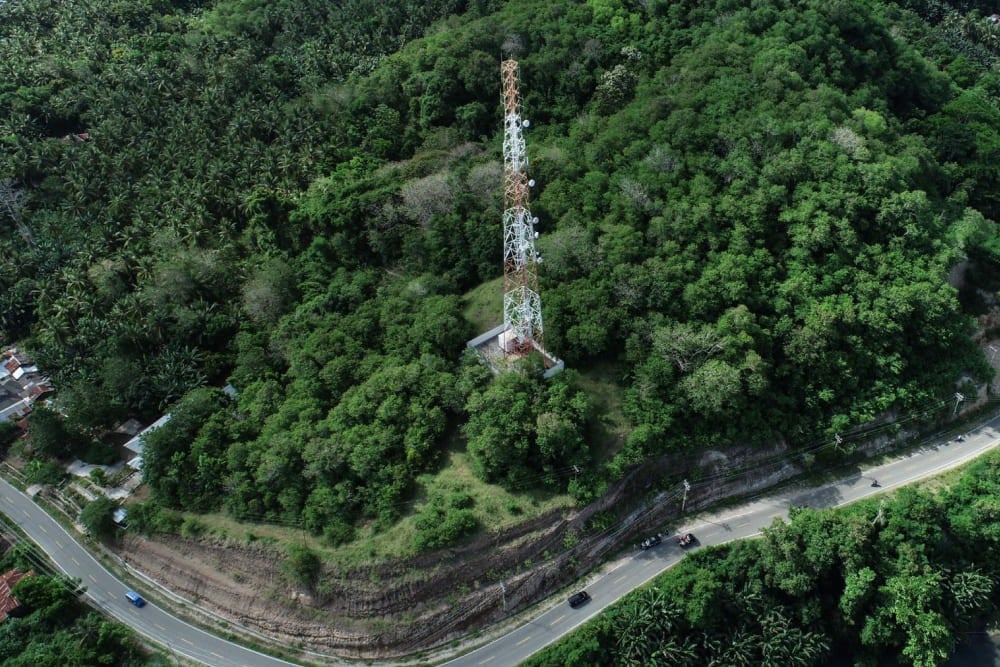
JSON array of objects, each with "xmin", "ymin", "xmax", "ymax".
[{"xmin": 0, "ymin": 479, "xmax": 293, "ymax": 667}]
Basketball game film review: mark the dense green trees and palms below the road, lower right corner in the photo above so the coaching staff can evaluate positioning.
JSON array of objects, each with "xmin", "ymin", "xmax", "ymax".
[{"xmin": 528, "ymin": 444, "xmax": 1000, "ymax": 665}]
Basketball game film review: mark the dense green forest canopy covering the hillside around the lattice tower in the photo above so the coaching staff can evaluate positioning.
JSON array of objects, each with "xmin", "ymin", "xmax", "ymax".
[{"xmin": 0, "ymin": 0, "xmax": 1000, "ymax": 535}]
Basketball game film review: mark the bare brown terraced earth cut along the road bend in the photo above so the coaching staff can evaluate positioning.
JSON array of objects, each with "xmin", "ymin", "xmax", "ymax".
[{"xmin": 120, "ymin": 438, "xmax": 812, "ymax": 659}]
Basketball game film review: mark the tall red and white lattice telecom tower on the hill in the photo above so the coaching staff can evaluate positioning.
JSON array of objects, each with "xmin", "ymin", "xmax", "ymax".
[{"xmin": 500, "ymin": 60, "xmax": 544, "ymax": 355}]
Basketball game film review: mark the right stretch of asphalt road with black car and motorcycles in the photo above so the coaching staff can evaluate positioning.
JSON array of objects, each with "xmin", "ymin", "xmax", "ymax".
[{"xmin": 444, "ymin": 417, "xmax": 1000, "ymax": 667}]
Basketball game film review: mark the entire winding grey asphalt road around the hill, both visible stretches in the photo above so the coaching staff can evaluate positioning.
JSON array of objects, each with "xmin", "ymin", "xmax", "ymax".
[{"xmin": 0, "ymin": 417, "xmax": 1000, "ymax": 667}]
